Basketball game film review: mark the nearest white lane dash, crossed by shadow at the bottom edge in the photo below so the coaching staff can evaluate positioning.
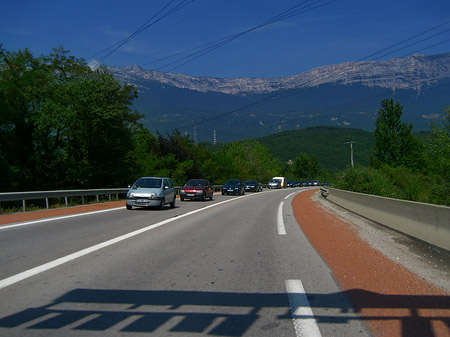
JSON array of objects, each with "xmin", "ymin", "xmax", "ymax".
[{"xmin": 286, "ymin": 280, "xmax": 322, "ymax": 337}]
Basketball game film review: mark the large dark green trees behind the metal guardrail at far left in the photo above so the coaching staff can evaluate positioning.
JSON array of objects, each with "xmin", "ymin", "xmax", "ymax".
[{"xmin": 0, "ymin": 48, "xmax": 141, "ymax": 190}]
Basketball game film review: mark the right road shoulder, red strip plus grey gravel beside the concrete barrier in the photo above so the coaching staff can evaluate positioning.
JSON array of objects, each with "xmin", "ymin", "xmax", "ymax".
[{"xmin": 292, "ymin": 190, "xmax": 450, "ymax": 336}]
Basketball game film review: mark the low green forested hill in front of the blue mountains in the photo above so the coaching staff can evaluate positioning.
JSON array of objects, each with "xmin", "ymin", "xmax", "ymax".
[{"xmin": 258, "ymin": 126, "xmax": 375, "ymax": 172}]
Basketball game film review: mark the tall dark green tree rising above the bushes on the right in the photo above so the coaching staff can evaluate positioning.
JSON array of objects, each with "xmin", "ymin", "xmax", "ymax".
[{"xmin": 371, "ymin": 99, "xmax": 424, "ymax": 170}]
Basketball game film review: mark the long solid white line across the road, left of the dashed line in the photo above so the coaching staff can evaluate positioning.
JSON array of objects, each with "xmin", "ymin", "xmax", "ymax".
[{"xmin": 0, "ymin": 195, "xmax": 246, "ymax": 289}]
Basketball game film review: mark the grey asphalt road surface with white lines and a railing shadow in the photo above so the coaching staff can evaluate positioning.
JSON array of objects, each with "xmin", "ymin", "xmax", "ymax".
[{"xmin": 0, "ymin": 189, "xmax": 450, "ymax": 336}]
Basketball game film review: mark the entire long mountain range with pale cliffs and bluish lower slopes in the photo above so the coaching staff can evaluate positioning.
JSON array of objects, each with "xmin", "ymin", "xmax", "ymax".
[{"xmin": 108, "ymin": 53, "xmax": 450, "ymax": 142}]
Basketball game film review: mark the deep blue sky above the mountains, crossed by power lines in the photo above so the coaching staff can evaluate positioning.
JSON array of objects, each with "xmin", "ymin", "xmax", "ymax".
[{"xmin": 0, "ymin": 0, "xmax": 450, "ymax": 77}]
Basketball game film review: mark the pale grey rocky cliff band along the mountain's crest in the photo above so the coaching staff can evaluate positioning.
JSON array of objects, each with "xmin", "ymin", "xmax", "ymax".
[{"xmin": 109, "ymin": 53, "xmax": 450, "ymax": 96}]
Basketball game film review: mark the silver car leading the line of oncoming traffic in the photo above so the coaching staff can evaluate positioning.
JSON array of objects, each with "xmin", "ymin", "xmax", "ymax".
[{"xmin": 127, "ymin": 177, "xmax": 176, "ymax": 209}]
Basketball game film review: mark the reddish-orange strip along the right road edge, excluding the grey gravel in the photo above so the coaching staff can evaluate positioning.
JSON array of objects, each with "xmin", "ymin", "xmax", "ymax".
[{"xmin": 292, "ymin": 190, "xmax": 450, "ymax": 337}]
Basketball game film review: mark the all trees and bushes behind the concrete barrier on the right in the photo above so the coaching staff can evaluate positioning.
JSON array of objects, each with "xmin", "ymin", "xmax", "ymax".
[{"xmin": 334, "ymin": 100, "xmax": 450, "ymax": 205}]
